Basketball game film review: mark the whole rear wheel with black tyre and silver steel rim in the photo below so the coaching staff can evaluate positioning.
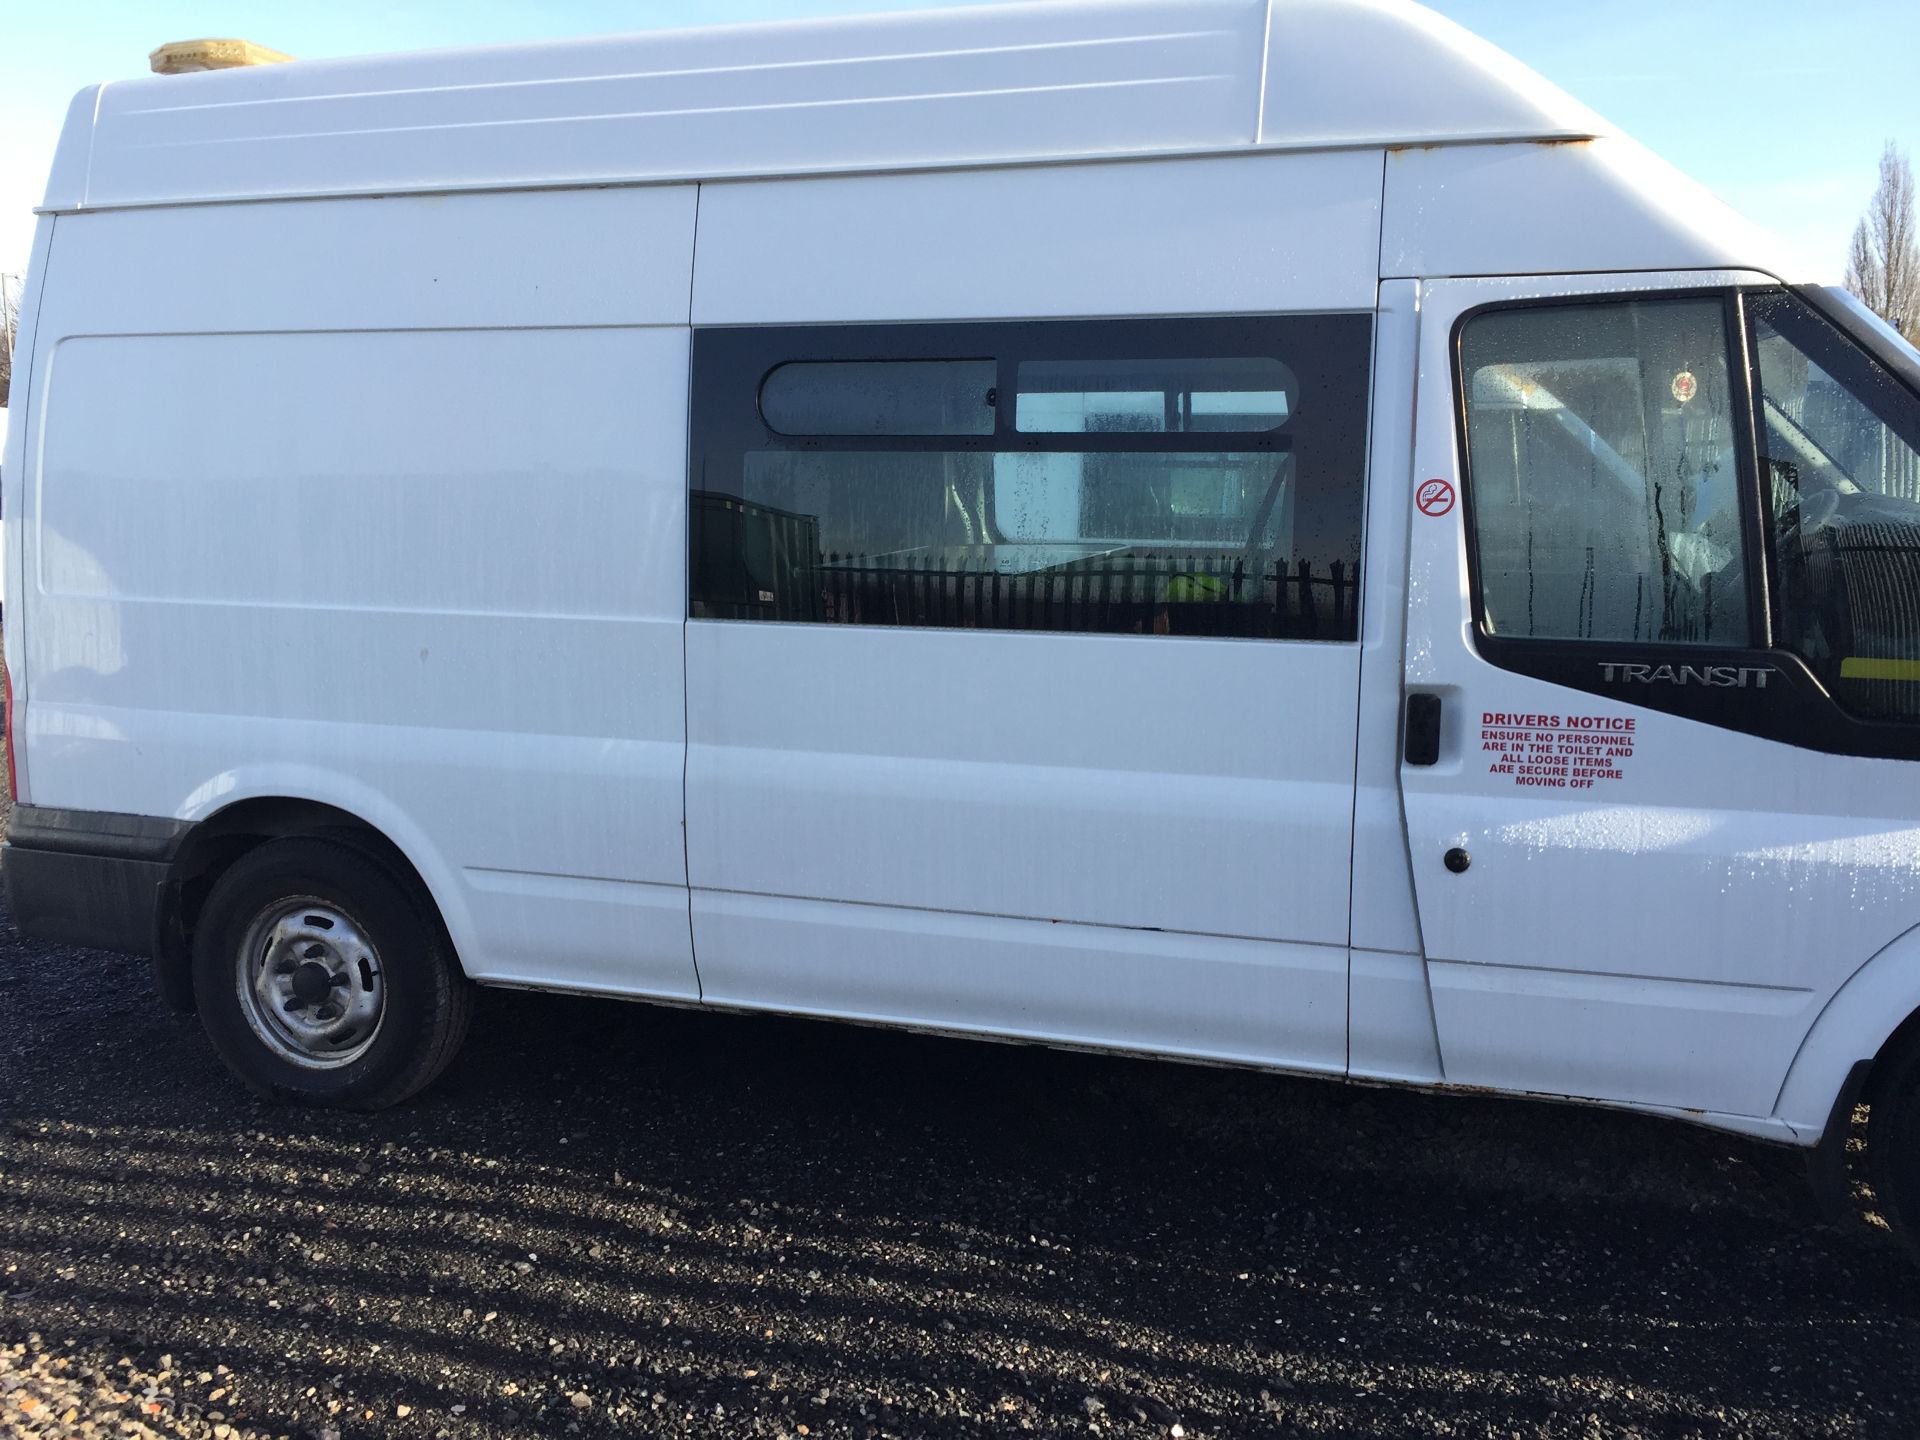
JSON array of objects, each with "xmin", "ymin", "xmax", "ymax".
[{"xmin": 194, "ymin": 839, "xmax": 472, "ymax": 1110}]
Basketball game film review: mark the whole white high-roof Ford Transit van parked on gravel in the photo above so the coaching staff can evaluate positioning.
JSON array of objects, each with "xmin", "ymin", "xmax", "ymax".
[{"xmin": 4, "ymin": 0, "xmax": 1920, "ymax": 1235}]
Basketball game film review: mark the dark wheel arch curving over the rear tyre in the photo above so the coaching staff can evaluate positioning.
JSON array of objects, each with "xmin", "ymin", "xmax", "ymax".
[{"xmin": 154, "ymin": 795, "xmax": 457, "ymax": 1012}]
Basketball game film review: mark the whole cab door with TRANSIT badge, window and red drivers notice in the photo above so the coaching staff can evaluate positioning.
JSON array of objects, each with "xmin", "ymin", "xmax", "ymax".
[{"xmin": 1402, "ymin": 275, "xmax": 1920, "ymax": 1116}]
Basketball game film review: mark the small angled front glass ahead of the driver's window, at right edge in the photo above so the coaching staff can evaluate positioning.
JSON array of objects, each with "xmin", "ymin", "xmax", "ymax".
[{"xmin": 1747, "ymin": 294, "xmax": 1920, "ymax": 720}]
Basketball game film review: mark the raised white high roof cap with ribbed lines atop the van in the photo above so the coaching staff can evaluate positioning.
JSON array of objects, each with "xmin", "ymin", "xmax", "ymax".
[{"xmin": 46, "ymin": 0, "xmax": 1605, "ymax": 209}]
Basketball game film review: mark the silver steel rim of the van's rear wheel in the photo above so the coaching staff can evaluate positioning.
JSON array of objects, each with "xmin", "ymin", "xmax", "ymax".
[{"xmin": 234, "ymin": 897, "xmax": 386, "ymax": 1069}]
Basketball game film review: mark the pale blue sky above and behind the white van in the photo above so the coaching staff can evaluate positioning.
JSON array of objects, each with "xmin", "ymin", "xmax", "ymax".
[{"xmin": 0, "ymin": 0, "xmax": 1920, "ymax": 276}]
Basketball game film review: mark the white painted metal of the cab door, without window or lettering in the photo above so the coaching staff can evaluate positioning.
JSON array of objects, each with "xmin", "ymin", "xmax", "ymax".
[{"xmin": 1402, "ymin": 271, "xmax": 1920, "ymax": 1135}]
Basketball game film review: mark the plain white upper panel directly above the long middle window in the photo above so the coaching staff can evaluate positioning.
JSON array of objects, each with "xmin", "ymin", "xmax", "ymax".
[{"xmin": 693, "ymin": 150, "xmax": 1380, "ymax": 324}]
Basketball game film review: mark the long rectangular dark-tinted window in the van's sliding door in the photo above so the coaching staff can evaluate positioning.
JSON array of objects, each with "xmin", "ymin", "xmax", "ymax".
[{"xmin": 689, "ymin": 324, "xmax": 1371, "ymax": 639}]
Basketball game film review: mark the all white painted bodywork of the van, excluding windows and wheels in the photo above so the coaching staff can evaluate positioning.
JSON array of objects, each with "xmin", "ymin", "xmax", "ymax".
[{"xmin": 4, "ymin": 0, "xmax": 1920, "ymax": 1142}]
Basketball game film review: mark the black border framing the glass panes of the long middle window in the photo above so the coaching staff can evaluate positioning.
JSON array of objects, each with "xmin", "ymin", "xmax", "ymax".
[{"xmin": 685, "ymin": 311, "xmax": 1375, "ymax": 643}]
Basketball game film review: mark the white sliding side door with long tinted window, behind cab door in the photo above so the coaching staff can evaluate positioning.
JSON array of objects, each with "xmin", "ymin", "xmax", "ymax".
[{"xmin": 687, "ymin": 315, "xmax": 1371, "ymax": 1069}]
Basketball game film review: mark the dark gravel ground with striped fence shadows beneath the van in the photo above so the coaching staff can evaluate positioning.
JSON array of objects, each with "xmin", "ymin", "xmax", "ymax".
[{"xmin": 0, "ymin": 890, "xmax": 1920, "ymax": 1440}]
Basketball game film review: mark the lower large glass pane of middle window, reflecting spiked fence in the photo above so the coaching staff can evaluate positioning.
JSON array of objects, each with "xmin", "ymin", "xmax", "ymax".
[{"xmin": 695, "ymin": 451, "xmax": 1305, "ymax": 636}]
